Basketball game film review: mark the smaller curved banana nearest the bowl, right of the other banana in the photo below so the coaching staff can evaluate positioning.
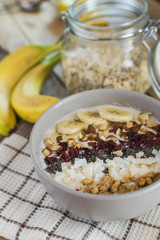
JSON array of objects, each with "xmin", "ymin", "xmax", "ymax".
[{"xmin": 11, "ymin": 53, "xmax": 60, "ymax": 123}]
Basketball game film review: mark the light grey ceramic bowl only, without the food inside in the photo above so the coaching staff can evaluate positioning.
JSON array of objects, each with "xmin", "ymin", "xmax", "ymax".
[{"xmin": 30, "ymin": 89, "xmax": 160, "ymax": 222}]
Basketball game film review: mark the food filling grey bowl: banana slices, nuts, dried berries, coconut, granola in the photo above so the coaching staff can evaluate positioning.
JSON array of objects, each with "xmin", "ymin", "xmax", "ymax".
[{"xmin": 41, "ymin": 105, "xmax": 160, "ymax": 195}]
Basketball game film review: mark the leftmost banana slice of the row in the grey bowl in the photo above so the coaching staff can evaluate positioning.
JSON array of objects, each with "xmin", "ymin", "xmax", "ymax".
[{"xmin": 56, "ymin": 119, "xmax": 87, "ymax": 134}]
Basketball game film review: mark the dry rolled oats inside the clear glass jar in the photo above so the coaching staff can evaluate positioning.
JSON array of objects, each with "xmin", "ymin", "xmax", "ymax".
[{"xmin": 62, "ymin": 44, "xmax": 150, "ymax": 93}]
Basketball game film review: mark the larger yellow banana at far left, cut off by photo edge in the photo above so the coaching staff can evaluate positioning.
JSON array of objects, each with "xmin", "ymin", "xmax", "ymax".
[{"xmin": 0, "ymin": 42, "xmax": 61, "ymax": 135}]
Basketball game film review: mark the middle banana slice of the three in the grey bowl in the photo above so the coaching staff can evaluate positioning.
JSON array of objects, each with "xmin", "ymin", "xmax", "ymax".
[{"xmin": 77, "ymin": 112, "xmax": 109, "ymax": 127}]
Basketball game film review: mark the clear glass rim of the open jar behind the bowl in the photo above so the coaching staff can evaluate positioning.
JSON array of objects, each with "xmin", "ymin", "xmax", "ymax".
[{"xmin": 68, "ymin": 0, "xmax": 149, "ymax": 40}]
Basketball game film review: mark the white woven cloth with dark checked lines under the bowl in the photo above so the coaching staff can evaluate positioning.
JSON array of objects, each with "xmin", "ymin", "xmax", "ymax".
[{"xmin": 0, "ymin": 122, "xmax": 160, "ymax": 240}]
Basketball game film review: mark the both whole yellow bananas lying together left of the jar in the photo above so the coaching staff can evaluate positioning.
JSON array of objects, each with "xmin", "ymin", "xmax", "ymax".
[{"xmin": 0, "ymin": 42, "xmax": 61, "ymax": 136}]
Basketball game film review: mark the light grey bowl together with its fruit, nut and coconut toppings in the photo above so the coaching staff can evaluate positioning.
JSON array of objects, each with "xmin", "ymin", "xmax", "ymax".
[{"xmin": 30, "ymin": 89, "xmax": 160, "ymax": 222}]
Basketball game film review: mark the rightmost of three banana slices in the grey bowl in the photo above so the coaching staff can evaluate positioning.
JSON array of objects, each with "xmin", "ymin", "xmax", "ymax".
[{"xmin": 99, "ymin": 108, "xmax": 133, "ymax": 122}]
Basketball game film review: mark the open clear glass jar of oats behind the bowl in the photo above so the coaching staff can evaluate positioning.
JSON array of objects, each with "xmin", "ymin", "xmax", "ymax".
[{"xmin": 61, "ymin": 0, "xmax": 159, "ymax": 93}]
